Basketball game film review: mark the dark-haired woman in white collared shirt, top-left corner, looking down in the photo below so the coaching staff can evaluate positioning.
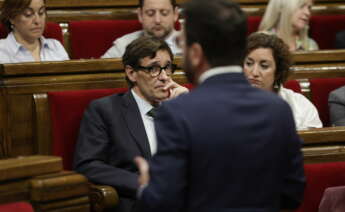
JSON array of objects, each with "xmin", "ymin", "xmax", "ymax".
[{"xmin": 0, "ymin": 0, "xmax": 69, "ymax": 63}]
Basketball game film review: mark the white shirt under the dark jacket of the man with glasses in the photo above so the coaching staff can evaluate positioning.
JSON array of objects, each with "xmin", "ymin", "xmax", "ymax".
[{"xmin": 131, "ymin": 89, "xmax": 157, "ymax": 155}]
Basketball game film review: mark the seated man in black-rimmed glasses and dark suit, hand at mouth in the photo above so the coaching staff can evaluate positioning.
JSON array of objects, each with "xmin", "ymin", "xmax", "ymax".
[{"xmin": 74, "ymin": 37, "xmax": 188, "ymax": 212}]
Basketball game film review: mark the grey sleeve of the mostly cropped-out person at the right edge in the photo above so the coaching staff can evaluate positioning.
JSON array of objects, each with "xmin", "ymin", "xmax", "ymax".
[{"xmin": 328, "ymin": 86, "xmax": 345, "ymax": 126}]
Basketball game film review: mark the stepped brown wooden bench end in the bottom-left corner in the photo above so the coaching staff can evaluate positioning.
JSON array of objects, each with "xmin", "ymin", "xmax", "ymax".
[{"xmin": 0, "ymin": 155, "xmax": 90, "ymax": 212}]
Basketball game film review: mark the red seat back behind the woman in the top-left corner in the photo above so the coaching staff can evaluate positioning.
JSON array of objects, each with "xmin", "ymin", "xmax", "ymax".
[{"xmin": 0, "ymin": 22, "xmax": 63, "ymax": 44}]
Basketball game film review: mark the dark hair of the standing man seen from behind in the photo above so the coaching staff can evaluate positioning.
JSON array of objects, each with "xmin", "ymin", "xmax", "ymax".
[{"xmin": 183, "ymin": 0, "xmax": 247, "ymax": 67}]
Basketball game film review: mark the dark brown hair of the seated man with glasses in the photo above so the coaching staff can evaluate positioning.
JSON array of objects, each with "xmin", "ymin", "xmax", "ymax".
[{"xmin": 122, "ymin": 36, "xmax": 174, "ymax": 88}]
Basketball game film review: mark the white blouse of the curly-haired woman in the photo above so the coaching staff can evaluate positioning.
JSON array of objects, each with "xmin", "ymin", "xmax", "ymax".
[{"xmin": 278, "ymin": 87, "xmax": 322, "ymax": 130}]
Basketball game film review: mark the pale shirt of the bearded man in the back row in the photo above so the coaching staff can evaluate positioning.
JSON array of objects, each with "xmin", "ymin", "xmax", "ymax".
[{"xmin": 102, "ymin": 30, "xmax": 182, "ymax": 58}]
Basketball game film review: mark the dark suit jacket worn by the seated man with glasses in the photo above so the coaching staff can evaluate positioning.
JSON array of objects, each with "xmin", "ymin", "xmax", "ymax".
[{"xmin": 74, "ymin": 92, "xmax": 151, "ymax": 212}]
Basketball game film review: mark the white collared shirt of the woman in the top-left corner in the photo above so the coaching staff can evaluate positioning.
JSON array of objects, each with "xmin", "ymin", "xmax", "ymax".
[{"xmin": 0, "ymin": 32, "xmax": 69, "ymax": 63}]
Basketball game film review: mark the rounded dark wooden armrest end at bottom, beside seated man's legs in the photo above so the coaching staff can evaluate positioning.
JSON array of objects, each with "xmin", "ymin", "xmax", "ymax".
[{"xmin": 90, "ymin": 184, "xmax": 119, "ymax": 212}]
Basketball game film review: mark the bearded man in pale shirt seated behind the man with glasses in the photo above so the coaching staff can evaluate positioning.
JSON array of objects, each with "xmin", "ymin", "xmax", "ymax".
[{"xmin": 102, "ymin": 0, "xmax": 181, "ymax": 58}]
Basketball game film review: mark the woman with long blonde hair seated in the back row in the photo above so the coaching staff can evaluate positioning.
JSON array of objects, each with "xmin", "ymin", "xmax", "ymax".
[{"xmin": 259, "ymin": 0, "xmax": 319, "ymax": 51}]
